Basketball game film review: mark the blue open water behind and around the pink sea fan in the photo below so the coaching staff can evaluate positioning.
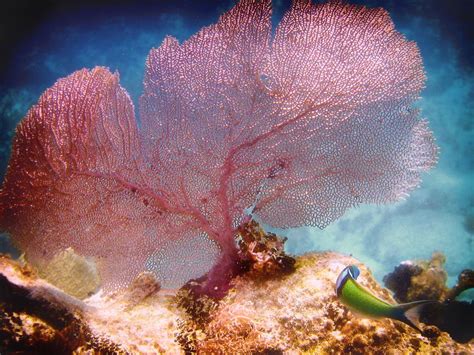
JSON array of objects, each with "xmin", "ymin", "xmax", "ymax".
[{"xmin": 0, "ymin": 0, "xmax": 474, "ymax": 284}]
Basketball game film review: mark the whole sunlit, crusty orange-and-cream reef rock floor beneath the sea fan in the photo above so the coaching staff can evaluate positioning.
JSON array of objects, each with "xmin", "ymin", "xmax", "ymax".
[{"xmin": 0, "ymin": 252, "xmax": 474, "ymax": 354}]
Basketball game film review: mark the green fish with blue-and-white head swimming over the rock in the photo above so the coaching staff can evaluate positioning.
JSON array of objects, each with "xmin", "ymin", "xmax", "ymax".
[{"xmin": 336, "ymin": 265, "xmax": 436, "ymax": 333}]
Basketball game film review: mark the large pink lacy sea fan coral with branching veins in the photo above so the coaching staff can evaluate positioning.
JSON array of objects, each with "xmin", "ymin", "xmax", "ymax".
[{"xmin": 0, "ymin": 0, "xmax": 437, "ymax": 294}]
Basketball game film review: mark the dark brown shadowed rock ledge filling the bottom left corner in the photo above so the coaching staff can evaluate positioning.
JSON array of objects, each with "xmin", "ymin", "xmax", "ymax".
[{"xmin": 0, "ymin": 256, "xmax": 126, "ymax": 354}]
